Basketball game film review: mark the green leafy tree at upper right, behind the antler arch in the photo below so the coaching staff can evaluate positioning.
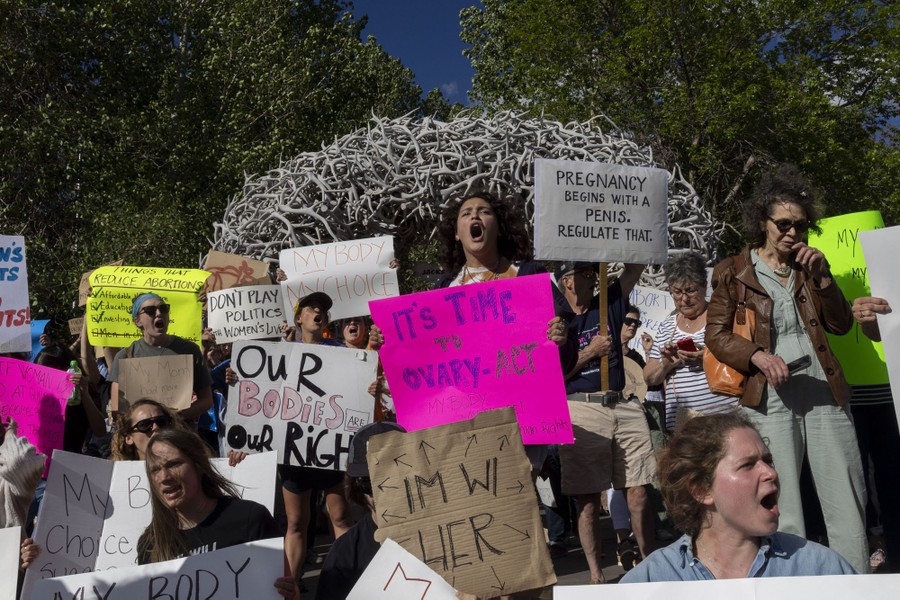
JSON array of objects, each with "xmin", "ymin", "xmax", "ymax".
[{"xmin": 461, "ymin": 0, "xmax": 900, "ymax": 244}]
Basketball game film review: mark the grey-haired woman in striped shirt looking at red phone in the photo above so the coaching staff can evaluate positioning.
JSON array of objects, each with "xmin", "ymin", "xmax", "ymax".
[{"xmin": 644, "ymin": 252, "xmax": 737, "ymax": 431}]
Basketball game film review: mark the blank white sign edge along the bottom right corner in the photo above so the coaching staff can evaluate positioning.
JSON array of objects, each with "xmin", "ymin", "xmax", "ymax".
[{"xmin": 553, "ymin": 574, "xmax": 900, "ymax": 600}]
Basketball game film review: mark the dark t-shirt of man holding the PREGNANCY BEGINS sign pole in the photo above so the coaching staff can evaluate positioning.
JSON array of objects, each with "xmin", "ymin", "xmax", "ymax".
[{"xmin": 566, "ymin": 281, "xmax": 625, "ymax": 394}]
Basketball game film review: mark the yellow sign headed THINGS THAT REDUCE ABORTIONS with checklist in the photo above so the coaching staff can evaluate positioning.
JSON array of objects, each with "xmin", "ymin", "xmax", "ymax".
[{"xmin": 85, "ymin": 266, "xmax": 209, "ymax": 348}]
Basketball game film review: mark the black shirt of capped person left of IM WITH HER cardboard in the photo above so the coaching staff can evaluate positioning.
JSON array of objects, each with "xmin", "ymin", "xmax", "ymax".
[{"xmin": 316, "ymin": 512, "xmax": 381, "ymax": 600}]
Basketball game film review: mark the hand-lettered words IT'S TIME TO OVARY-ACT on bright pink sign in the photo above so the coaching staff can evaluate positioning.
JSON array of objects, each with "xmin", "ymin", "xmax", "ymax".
[{"xmin": 391, "ymin": 286, "xmax": 537, "ymax": 390}]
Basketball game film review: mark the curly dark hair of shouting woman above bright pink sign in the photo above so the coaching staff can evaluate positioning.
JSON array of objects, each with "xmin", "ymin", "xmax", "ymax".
[{"xmin": 438, "ymin": 189, "xmax": 534, "ymax": 276}]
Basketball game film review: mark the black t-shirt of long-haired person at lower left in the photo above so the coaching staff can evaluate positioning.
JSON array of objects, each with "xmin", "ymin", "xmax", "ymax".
[{"xmin": 138, "ymin": 496, "xmax": 282, "ymax": 565}]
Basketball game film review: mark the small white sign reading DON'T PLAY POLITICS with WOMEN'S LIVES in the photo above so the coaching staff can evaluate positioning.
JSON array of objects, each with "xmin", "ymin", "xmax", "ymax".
[{"xmin": 206, "ymin": 285, "xmax": 289, "ymax": 344}]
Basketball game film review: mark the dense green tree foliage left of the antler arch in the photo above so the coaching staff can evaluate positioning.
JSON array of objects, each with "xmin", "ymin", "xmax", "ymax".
[{"xmin": 0, "ymin": 0, "xmax": 441, "ymax": 324}]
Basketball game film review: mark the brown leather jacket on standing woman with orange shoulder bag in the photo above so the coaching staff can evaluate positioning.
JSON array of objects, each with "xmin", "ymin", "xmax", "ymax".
[{"xmin": 705, "ymin": 246, "xmax": 853, "ymax": 406}]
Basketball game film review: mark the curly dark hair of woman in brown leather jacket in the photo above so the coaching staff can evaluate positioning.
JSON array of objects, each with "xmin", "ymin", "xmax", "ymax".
[{"xmin": 744, "ymin": 164, "xmax": 822, "ymax": 248}]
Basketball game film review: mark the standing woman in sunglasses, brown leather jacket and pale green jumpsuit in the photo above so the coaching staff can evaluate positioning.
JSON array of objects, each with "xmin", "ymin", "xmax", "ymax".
[{"xmin": 706, "ymin": 166, "xmax": 868, "ymax": 573}]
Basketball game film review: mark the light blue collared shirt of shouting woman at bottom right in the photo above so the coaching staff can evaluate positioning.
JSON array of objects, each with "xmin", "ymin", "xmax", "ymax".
[{"xmin": 620, "ymin": 532, "xmax": 856, "ymax": 583}]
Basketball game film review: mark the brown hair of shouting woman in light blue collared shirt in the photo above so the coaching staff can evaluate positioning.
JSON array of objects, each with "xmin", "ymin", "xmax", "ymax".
[{"xmin": 657, "ymin": 411, "xmax": 759, "ymax": 537}]
